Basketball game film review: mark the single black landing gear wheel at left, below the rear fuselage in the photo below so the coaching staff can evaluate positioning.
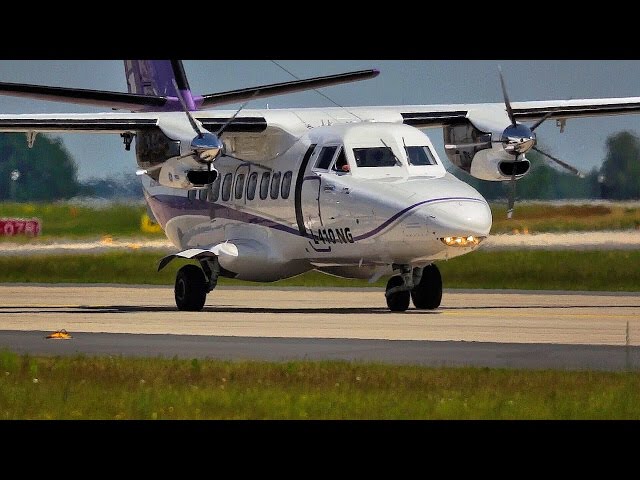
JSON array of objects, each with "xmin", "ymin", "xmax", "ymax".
[{"xmin": 174, "ymin": 257, "xmax": 220, "ymax": 312}]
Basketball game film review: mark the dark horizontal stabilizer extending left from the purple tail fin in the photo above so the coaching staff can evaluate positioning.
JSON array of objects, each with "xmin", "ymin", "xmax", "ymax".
[{"xmin": 0, "ymin": 83, "xmax": 167, "ymax": 110}]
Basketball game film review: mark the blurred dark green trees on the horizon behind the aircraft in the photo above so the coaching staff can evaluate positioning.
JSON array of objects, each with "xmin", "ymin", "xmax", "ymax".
[{"xmin": 0, "ymin": 131, "xmax": 640, "ymax": 202}]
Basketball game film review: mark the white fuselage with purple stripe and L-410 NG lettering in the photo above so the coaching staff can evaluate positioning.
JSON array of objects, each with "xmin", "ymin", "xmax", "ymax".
[{"xmin": 143, "ymin": 122, "xmax": 492, "ymax": 281}]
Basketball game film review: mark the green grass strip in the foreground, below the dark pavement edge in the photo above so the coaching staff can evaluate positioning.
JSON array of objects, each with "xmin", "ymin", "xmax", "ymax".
[{"xmin": 0, "ymin": 351, "xmax": 640, "ymax": 420}]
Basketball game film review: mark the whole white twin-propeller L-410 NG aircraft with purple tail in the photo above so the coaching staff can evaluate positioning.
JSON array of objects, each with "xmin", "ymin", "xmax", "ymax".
[{"xmin": 0, "ymin": 60, "xmax": 640, "ymax": 311}]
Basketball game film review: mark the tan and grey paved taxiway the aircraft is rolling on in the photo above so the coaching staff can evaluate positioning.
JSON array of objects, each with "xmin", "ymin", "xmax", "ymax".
[{"xmin": 0, "ymin": 284, "xmax": 640, "ymax": 370}]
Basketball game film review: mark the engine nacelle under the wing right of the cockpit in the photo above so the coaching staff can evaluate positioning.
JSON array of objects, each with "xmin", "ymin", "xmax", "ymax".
[{"xmin": 443, "ymin": 121, "xmax": 531, "ymax": 182}]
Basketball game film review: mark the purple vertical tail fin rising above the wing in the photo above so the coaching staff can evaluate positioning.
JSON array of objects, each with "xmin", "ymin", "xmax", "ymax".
[{"xmin": 124, "ymin": 60, "xmax": 196, "ymax": 111}]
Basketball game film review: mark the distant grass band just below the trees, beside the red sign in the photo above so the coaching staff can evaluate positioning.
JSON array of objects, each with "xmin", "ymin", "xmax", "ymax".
[{"xmin": 0, "ymin": 202, "xmax": 640, "ymax": 241}]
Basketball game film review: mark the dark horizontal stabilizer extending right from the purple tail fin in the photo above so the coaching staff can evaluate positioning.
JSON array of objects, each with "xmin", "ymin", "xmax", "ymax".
[{"xmin": 200, "ymin": 70, "xmax": 380, "ymax": 108}]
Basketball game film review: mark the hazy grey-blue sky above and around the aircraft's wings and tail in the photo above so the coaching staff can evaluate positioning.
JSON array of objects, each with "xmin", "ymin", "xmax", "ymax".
[{"xmin": 0, "ymin": 60, "xmax": 640, "ymax": 179}]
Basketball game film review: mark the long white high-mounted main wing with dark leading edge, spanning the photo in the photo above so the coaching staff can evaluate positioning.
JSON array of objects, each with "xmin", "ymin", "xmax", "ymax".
[{"xmin": 0, "ymin": 97, "xmax": 640, "ymax": 140}]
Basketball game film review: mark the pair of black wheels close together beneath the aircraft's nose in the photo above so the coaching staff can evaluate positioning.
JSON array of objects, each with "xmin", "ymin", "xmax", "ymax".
[{"xmin": 385, "ymin": 264, "xmax": 442, "ymax": 312}]
